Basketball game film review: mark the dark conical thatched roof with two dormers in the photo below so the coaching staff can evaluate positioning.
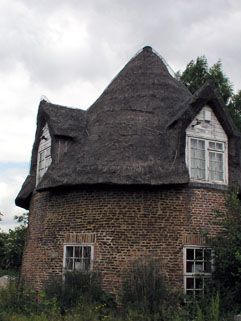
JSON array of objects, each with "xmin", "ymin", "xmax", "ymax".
[{"xmin": 16, "ymin": 47, "xmax": 241, "ymax": 207}]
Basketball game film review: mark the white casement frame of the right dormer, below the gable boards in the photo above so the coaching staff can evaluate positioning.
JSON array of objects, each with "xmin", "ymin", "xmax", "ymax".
[{"xmin": 186, "ymin": 136, "xmax": 228, "ymax": 185}]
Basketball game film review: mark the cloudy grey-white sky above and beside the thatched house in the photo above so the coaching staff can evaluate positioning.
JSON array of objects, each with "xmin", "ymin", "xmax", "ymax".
[{"xmin": 0, "ymin": 0, "xmax": 241, "ymax": 232}]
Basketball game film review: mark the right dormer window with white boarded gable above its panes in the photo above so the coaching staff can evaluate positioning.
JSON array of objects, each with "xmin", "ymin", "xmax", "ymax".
[{"xmin": 186, "ymin": 106, "xmax": 228, "ymax": 184}]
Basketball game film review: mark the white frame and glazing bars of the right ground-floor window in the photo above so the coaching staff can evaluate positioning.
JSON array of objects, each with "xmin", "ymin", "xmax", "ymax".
[{"xmin": 183, "ymin": 245, "xmax": 214, "ymax": 297}]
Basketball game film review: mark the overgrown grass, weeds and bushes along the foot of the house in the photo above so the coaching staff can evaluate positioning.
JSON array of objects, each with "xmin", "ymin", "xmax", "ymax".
[{"xmin": 0, "ymin": 259, "xmax": 238, "ymax": 321}]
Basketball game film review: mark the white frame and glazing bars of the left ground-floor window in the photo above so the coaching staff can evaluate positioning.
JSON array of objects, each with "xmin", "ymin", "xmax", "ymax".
[{"xmin": 63, "ymin": 243, "xmax": 94, "ymax": 272}]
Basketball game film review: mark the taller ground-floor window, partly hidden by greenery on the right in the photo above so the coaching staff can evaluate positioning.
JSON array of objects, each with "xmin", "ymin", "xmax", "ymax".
[{"xmin": 183, "ymin": 246, "xmax": 213, "ymax": 296}]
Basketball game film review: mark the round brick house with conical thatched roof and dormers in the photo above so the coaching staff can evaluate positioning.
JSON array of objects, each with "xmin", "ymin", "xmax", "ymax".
[{"xmin": 16, "ymin": 47, "xmax": 241, "ymax": 294}]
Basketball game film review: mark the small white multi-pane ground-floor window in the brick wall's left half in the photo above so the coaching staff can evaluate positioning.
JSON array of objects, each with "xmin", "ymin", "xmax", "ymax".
[{"xmin": 64, "ymin": 244, "xmax": 94, "ymax": 272}]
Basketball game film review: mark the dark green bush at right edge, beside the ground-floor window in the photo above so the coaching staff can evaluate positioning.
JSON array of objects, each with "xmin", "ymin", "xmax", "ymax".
[{"xmin": 208, "ymin": 190, "xmax": 241, "ymax": 309}]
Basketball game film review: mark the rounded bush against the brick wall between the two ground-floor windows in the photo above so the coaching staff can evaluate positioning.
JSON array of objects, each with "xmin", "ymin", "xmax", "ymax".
[{"xmin": 121, "ymin": 258, "xmax": 167, "ymax": 315}]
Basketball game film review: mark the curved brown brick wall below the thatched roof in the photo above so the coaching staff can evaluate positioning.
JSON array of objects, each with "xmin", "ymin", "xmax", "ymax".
[{"xmin": 22, "ymin": 187, "xmax": 225, "ymax": 293}]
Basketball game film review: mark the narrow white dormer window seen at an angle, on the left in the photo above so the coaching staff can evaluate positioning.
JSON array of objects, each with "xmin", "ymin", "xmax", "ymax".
[{"xmin": 36, "ymin": 123, "xmax": 52, "ymax": 184}]
